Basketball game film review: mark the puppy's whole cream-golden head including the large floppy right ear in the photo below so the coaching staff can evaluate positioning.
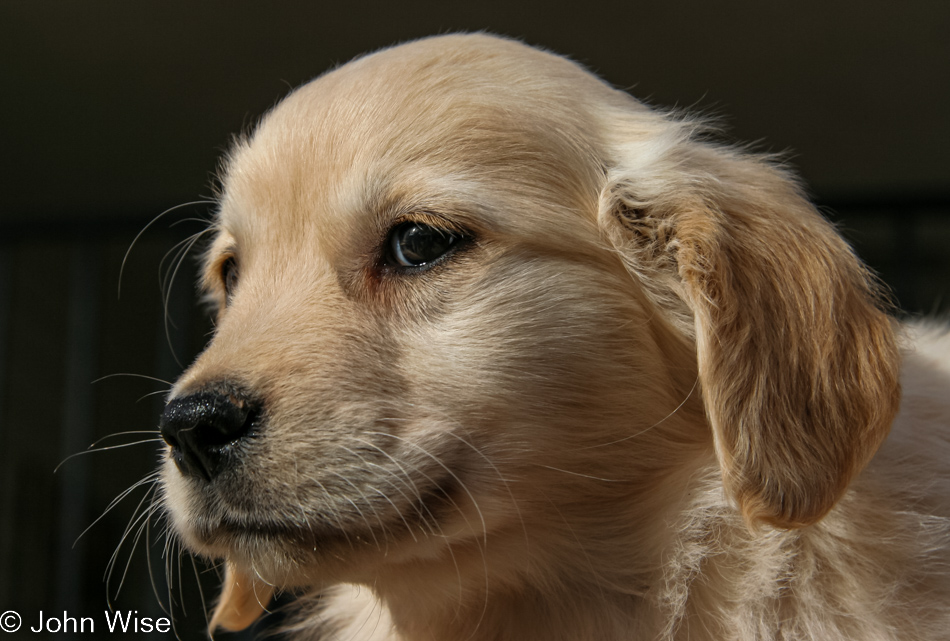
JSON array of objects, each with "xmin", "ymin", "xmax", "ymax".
[{"xmin": 162, "ymin": 36, "xmax": 898, "ymax": 623}]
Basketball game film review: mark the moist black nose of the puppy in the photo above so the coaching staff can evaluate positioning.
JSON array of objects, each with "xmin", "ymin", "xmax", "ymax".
[{"xmin": 159, "ymin": 392, "xmax": 260, "ymax": 481}]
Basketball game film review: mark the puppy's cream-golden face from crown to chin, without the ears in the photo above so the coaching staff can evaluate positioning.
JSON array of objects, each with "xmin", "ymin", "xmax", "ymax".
[{"xmin": 163, "ymin": 32, "xmax": 676, "ymax": 596}]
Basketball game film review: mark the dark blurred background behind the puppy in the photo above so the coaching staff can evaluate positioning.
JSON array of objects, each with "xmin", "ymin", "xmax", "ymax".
[{"xmin": 0, "ymin": 0, "xmax": 950, "ymax": 639}]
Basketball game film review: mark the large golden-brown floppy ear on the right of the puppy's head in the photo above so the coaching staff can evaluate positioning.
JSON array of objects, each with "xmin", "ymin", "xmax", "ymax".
[{"xmin": 599, "ymin": 137, "xmax": 900, "ymax": 528}]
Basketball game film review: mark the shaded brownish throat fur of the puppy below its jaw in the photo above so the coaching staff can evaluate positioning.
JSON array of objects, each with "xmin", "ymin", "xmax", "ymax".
[{"xmin": 338, "ymin": 448, "xmax": 715, "ymax": 641}]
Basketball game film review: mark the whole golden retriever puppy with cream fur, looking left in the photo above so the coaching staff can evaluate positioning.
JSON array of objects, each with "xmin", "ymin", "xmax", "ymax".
[{"xmin": 161, "ymin": 35, "xmax": 950, "ymax": 641}]
